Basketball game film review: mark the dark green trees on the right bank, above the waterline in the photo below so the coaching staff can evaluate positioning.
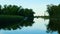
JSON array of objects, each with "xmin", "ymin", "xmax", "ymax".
[{"xmin": 47, "ymin": 5, "xmax": 60, "ymax": 18}]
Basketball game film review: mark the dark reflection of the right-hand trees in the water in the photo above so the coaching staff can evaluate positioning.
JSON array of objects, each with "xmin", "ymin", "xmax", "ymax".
[{"xmin": 47, "ymin": 18, "xmax": 60, "ymax": 34}]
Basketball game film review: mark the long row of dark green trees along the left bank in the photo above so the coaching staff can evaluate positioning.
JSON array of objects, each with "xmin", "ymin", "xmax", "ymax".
[{"xmin": 0, "ymin": 5, "xmax": 34, "ymax": 16}]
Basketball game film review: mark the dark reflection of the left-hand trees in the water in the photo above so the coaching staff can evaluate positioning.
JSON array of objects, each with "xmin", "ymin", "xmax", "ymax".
[{"xmin": 0, "ymin": 17, "xmax": 34, "ymax": 30}]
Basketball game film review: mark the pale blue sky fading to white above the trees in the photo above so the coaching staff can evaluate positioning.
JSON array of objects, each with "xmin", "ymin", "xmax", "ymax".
[{"xmin": 0, "ymin": 0, "xmax": 60, "ymax": 16}]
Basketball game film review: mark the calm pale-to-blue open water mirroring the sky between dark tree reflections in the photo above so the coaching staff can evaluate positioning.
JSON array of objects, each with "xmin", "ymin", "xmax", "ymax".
[{"xmin": 0, "ymin": 18, "xmax": 57, "ymax": 34}]
